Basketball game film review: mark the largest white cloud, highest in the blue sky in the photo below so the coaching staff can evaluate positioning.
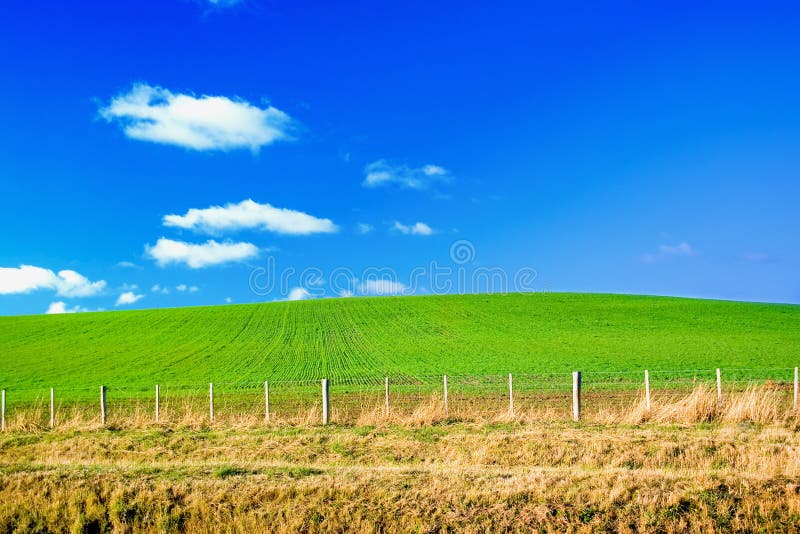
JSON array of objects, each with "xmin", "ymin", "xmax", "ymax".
[{"xmin": 100, "ymin": 83, "xmax": 294, "ymax": 151}]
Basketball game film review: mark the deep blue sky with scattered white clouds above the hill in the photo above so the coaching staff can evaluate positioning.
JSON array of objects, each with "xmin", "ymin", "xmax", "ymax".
[{"xmin": 0, "ymin": 0, "xmax": 800, "ymax": 314}]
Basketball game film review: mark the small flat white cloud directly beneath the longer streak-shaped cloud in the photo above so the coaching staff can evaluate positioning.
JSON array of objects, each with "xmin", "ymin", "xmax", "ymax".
[{"xmin": 145, "ymin": 237, "xmax": 258, "ymax": 269}]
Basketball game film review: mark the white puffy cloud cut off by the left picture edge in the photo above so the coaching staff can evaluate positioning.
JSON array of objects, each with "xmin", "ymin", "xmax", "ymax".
[{"xmin": 0, "ymin": 265, "xmax": 106, "ymax": 298}]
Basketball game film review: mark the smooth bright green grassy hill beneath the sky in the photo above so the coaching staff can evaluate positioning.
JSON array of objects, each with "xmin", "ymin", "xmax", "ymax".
[{"xmin": 0, "ymin": 293, "xmax": 800, "ymax": 389}]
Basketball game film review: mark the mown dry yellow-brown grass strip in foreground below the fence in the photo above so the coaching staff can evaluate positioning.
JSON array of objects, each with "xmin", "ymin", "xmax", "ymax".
[{"xmin": 0, "ymin": 420, "xmax": 800, "ymax": 532}]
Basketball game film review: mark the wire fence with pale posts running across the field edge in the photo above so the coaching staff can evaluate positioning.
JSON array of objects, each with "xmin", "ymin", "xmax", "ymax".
[{"xmin": 1, "ymin": 368, "xmax": 798, "ymax": 430}]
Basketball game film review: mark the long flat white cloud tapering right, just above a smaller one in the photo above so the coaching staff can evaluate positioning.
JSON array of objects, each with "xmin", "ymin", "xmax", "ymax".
[{"xmin": 164, "ymin": 199, "xmax": 338, "ymax": 235}]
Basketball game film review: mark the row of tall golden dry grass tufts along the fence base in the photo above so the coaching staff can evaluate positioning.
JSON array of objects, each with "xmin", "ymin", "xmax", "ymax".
[{"xmin": 7, "ymin": 384, "xmax": 796, "ymax": 432}]
